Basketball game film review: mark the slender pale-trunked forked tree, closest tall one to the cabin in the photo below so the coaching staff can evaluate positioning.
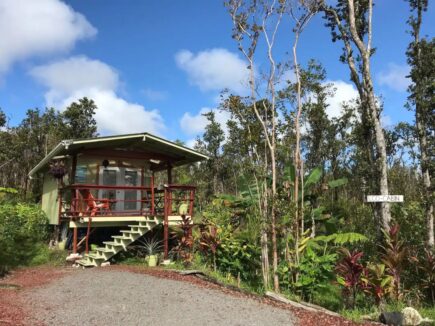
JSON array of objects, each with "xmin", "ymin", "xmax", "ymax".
[{"xmin": 226, "ymin": 0, "xmax": 287, "ymax": 291}]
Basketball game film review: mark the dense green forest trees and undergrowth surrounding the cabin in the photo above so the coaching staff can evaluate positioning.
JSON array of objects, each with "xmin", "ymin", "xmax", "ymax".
[{"xmin": 0, "ymin": 0, "xmax": 435, "ymax": 322}]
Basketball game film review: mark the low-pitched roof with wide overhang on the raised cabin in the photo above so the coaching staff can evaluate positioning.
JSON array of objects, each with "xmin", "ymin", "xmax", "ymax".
[{"xmin": 29, "ymin": 133, "xmax": 209, "ymax": 178}]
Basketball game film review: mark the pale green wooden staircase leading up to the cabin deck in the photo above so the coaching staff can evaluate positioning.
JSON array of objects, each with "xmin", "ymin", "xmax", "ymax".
[{"xmin": 77, "ymin": 218, "xmax": 160, "ymax": 267}]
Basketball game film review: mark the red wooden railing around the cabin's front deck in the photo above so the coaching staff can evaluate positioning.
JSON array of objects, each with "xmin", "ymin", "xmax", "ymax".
[{"xmin": 59, "ymin": 184, "xmax": 196, "ymax": 219}]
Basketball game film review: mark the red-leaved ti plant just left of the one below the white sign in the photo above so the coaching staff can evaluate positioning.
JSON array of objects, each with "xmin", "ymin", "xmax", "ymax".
[{"xmin": 335, "ymin": 248, "xmax": 365, "ymax": 308}]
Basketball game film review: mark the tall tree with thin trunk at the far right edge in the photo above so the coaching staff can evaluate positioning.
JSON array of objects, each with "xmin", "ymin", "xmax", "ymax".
[{"xmin": 406, "ymin": 0, "xmax": 435, "ymax": 248}]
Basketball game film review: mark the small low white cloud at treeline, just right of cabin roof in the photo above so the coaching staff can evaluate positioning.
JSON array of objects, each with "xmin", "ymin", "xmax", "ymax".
[{"xmin": 180, "ymin": 108, "xmax": 230, "ymax": 136}]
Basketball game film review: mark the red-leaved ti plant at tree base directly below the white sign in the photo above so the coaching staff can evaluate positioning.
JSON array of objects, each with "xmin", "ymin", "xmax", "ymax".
[{"xmin": 380, "ymin": 224, "xmax": 408, "ymax": 300}]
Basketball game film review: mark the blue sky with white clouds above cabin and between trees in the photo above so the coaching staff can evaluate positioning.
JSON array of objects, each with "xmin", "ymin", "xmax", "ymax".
[{"xmin": 0, "ymin": 0, "xmax": 435, "ymax": 144}]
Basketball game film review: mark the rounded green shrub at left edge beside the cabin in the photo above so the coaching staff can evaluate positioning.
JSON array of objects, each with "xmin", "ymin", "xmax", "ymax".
[{"xmin": 0, "ymin": 203, "xmax": 48, "ymax": 274}]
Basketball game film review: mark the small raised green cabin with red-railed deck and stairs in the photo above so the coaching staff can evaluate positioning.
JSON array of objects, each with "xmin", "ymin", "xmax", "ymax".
[{"xmin": 29, "ymin": 133, "xmax": 208, "ymax": 266}]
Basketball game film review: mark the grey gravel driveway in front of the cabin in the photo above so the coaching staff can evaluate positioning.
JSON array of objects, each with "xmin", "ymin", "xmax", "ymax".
[{"xmin": 25, "ymin": 268, "xmax": 295, "ymax": 326}]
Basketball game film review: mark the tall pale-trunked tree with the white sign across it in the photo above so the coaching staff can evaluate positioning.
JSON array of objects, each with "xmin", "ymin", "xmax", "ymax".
[{"xmin": 323, "ymin": 0, "xmax": 391, "ymax": 232}]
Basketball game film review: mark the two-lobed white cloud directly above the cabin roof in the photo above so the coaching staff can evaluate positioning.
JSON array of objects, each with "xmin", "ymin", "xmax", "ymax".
[{"xmin": 30, "ymin": 56, "xmax": 164, "ymax": 135}]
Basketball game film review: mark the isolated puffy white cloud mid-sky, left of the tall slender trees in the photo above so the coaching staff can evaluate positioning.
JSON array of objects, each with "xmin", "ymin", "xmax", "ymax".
[{"xmin": 175, "ymin": 48, "xmax": 248, "ymax": 93}]
